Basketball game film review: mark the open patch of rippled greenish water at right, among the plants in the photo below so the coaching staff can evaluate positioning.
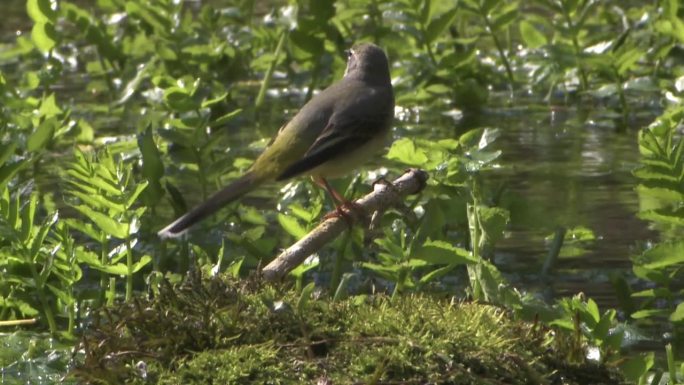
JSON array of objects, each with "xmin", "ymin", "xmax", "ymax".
[{"xmin": 456, "ymin": 106, "xmax": 656, "ymax": 306}]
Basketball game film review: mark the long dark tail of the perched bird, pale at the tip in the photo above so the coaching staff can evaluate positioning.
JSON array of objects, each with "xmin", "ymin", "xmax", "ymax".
[{"xmin": 157, "ymin": 172, "xmax": 261, "ymax": 238}]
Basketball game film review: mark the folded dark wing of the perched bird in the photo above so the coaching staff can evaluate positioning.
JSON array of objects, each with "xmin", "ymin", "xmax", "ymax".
[{"xmin": 276, "ymin": 116, "xmax": 384, "ymax": 181}]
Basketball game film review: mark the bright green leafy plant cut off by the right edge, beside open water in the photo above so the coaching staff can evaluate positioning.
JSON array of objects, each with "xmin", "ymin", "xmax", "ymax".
[{"xmin": 631, "ymin": 106, "xmax": 684, "ymax": 354}]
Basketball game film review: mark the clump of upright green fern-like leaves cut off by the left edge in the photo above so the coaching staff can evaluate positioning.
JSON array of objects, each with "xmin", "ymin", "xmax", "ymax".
[{"xmin": 0, "ymin": 188, "xmax": 75, "ymax": 333}]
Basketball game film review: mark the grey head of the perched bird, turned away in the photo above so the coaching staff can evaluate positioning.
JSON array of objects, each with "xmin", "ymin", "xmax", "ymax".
[{"xmin": 344, "ymin": 43, "xmax": 390, "ymax": 84}]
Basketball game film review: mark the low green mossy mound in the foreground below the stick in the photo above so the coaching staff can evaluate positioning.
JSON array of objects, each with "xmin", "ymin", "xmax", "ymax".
[{"xmin": 72, "ymin": 272, "xmax": 620, "ymax": 384}]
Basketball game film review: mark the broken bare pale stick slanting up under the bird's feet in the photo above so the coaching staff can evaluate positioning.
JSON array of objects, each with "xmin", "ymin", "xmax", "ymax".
[{"xmin": 262, "ymin": 169, "xmax": 428, "ymax": 281}]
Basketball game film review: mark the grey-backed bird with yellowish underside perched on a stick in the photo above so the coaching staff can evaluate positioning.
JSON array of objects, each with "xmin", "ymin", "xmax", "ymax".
[{"xmin": 158, "ymin": 43, "xmax": 394, "ymax": 237}]
